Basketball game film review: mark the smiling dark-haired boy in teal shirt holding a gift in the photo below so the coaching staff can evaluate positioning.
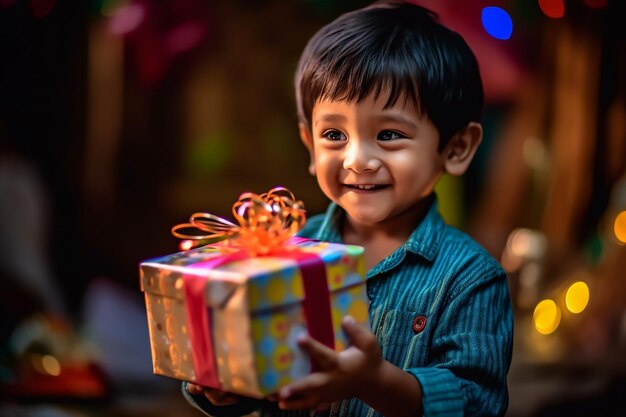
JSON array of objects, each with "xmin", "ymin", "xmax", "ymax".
[{"xmin": 184, "ymin": 3, "xmax": 513, "ymax": 416}]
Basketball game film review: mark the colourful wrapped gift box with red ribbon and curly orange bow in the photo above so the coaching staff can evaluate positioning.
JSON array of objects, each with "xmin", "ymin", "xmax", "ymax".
[{"xmin": 140, "ymin": 188, "xmax": 368, "ymax": 398}]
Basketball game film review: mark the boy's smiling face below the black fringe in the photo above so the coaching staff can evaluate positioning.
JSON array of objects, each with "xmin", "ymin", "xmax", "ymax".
[{"xmin": 301, "ymin": 94, "xmax": 445, "ymax": 226}]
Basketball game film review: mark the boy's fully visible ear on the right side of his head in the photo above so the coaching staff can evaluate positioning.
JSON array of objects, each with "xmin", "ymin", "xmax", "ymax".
[{"xmin": 442, "ymin": 122, "xmax": 483, "ymax": 175}]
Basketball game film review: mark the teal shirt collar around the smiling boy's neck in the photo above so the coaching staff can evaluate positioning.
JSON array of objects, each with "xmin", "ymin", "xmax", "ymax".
[{"xmin": 308, "ymin": 194, "xmax": 446, "ymax": 261}]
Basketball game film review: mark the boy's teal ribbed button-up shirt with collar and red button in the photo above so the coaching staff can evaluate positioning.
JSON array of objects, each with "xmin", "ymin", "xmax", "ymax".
[{"xmin": 183, "ymin": 198, "xmax": 513, "ymax": 417}]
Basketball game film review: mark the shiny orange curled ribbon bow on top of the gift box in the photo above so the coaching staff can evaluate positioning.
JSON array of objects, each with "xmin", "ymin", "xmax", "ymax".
[{"xmin": 172, "ymin": 187, "xmax": 306, "ymax": 255}]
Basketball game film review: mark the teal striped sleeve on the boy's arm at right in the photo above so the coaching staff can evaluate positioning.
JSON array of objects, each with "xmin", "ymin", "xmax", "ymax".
[{"xmin": 407, "ymin": 269, "xmax": 513, "ymax": 417}]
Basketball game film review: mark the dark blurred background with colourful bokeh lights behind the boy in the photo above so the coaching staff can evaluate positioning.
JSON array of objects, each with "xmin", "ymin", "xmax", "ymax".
[{"xmin": 0, "ymin": 0, "xmax": 626, "ymax": 417}]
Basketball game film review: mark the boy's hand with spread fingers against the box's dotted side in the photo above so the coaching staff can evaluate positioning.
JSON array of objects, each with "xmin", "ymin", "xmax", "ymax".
[{"xmin": 278, "ymin": 317, "xmax": 384, "ymax": 410}]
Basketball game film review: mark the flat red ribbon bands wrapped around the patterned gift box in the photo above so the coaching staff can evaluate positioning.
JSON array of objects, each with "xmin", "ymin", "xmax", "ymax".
[{"xmin": 183, "ymin": 238, "xmax": 335, "ymax": 388}]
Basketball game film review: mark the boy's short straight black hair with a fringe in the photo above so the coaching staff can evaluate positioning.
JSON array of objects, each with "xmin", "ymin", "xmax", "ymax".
[{"xmin": 295, "ymin": 2, "xmax": 483, "ymax": 150}]
